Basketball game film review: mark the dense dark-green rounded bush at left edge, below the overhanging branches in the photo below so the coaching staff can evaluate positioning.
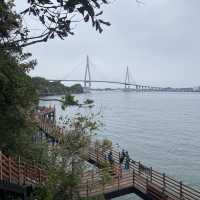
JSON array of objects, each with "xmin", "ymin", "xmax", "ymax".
[{"xmin": 0, "ymin": 51, "xmax": 38, "ymax": 156}]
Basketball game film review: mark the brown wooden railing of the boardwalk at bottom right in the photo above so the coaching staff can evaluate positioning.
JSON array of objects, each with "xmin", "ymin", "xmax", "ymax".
[{"xmin": 80, "ymin": 145, "xmax": 200, "ymax": 200}]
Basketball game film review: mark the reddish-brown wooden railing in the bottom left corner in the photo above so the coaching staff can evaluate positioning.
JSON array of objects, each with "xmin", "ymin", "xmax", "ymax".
[{"xmin": 0, "ymin": 151, "xmax": 47, "ymax": 185}]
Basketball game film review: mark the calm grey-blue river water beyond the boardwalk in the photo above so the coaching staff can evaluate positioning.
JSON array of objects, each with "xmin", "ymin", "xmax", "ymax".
[{"xmin": 41, "ymin": 91, "xmax": 200, "ymax": 200}]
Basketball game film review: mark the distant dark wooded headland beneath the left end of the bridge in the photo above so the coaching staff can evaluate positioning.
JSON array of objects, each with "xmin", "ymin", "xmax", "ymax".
[{"xmin": 32, "ymin": 77, "xmax": 83, "ymax": 96}]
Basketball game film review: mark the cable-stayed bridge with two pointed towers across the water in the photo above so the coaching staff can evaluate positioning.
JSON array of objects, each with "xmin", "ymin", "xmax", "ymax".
[{"xmin": 48, "ymin": 56, "xmax": 164, "ymax": 91}]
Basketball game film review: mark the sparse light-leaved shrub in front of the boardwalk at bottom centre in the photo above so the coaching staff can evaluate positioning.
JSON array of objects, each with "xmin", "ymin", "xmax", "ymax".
[{"xmin": 28, "ymin": 111, "xmax": 101, "ymax": 200}]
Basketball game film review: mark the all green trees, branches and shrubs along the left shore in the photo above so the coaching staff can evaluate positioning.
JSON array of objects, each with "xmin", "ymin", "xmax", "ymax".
[{"xmin": 0, "ymin": 0, "xmax": 109, "ymax": 200}]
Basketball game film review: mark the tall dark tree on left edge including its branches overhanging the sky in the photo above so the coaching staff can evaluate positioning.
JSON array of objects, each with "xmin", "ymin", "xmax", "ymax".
[{"xmin": 0, "ymin": 0, "xmax": 107, "ymax": 159}]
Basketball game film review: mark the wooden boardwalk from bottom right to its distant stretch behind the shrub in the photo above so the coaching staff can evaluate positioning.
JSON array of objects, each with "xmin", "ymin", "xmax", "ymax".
[{"xmin": 36, "ymin": 108, "xmax": 200, "ymax": 200}]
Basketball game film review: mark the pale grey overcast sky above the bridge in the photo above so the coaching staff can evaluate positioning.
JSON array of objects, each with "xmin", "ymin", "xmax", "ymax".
[{"xmin": 16, "ymin": 0, "xmax": 200, "ymax": 87}]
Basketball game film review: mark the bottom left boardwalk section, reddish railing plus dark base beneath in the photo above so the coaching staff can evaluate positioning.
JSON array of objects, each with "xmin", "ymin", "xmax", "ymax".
[{"xmin": 0, "ymin": 151, "xmax": 47, "ymax": 200}]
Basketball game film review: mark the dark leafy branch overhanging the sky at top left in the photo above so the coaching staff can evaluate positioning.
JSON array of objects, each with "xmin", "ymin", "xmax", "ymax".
[{"xmin": 0, "ymin": 0, "xmax": 110, "ymax": 49}]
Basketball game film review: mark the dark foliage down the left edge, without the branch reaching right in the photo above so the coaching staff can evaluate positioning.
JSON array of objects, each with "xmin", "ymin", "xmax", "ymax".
[{"xmin": 0, "ymin": 1, "xmax": 52, "ymax": 160}]
